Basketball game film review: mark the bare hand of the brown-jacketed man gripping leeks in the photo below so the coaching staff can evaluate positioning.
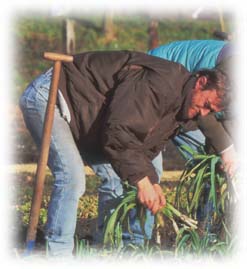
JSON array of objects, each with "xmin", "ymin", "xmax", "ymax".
[{"xmin": 137, "ymin": 177, "xmax": 166, "ymax": 214}]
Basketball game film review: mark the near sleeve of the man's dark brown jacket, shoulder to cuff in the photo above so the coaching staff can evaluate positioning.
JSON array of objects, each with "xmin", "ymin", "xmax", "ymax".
[{"xmin": 102, "ymin": 71, "xmax": 160, "ymax": 184}]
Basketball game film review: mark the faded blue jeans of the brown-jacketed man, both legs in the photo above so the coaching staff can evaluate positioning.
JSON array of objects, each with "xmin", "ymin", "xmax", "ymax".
[{"xmin": 19, "ymin": 70, "xmax": 162, "ymax": 256}]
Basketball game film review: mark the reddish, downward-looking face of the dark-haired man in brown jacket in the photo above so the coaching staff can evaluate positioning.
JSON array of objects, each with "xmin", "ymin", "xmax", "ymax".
[{"xmin": 188, "ymin": 76, "xmax": 221, "ymax": 119}]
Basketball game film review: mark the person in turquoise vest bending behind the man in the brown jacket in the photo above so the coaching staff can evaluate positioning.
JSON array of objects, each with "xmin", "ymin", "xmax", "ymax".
[{"xmin": 148, "ymin": 40, "xmax": 237, "ymax": 176}]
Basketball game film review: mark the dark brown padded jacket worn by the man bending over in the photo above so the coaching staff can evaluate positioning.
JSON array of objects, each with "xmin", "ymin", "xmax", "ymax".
[{"xmin": 59, "ymin": 51, "xmax": 195, "ymax": 184}]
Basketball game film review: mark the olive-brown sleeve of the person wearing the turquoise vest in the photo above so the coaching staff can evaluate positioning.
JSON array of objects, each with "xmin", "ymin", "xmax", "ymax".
[{"xmin": 198, "ymin": 113, "xmax": 233, "ymax": 153}]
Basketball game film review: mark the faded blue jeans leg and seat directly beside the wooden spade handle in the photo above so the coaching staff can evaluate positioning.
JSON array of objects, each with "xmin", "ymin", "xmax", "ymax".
[{"xmin": 20, "ymin": 68, "xmax": 85, "ymax": 256}]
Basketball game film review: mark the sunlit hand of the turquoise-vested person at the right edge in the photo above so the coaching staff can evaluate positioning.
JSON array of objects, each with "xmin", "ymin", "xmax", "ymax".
[{"xmin": 221, "ymin": 146, "xmax": 237, "ymax": 177}]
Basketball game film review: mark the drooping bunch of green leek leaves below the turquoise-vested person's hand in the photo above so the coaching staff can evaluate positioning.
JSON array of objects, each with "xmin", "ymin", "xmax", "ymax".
[{"xmin": 176, "ymin": 147, "xmax": 234, "ymax": 221}]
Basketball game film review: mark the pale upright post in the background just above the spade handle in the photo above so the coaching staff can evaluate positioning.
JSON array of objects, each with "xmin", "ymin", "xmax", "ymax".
[{"xmin": 63, "ymin": 19, "xmax": 75, "ymax": 54}]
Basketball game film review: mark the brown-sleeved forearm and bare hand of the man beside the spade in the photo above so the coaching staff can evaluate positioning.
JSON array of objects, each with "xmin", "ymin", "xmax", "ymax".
[{"xmin": 103, "ymin": 115, "xmax": 165, "ymax": 214}]
